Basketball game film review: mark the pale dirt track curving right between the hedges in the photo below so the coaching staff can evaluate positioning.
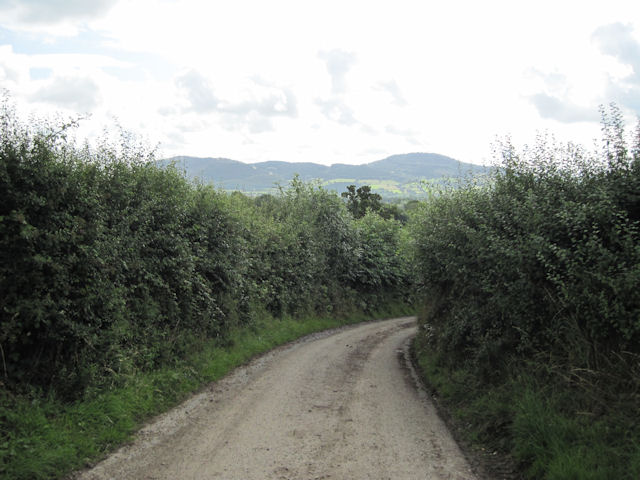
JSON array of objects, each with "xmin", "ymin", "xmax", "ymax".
[{"xmin": 77, "ymin": 318, "xmax": 475, "ymax": 480}]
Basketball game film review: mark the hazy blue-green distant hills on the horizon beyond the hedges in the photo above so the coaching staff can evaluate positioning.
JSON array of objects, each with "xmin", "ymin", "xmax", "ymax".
[{"xmin": 158, "ymin": 153, "xmax": 485, "ymax": 197}]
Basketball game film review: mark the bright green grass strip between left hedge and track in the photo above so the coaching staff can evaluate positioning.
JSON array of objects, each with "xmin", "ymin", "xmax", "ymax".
[{"xmin": 0, "ymin": 305, "xmax": 413, "ymax": 480}]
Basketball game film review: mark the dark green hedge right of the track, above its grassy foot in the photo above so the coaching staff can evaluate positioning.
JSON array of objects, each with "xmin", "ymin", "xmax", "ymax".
[{"xmin": 415, "ymin": 108, "xmax": 640, "ymax": 375}]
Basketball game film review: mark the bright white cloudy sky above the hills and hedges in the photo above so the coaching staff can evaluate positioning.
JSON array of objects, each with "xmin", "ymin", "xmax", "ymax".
[{"xmin": 0, "ymin": 0, "xmax": 640, "ymax": 165}]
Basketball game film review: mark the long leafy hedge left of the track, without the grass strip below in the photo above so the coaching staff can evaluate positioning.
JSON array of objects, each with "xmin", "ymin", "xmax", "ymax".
[{"xmin": 0, "ymin": 102, "xmax": 412, "ymax": 399}]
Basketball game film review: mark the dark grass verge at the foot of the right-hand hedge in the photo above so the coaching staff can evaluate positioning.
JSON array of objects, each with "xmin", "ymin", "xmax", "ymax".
[{"xmin": 413, "ymin": 339, "xmax": 640, "ymax": 480}]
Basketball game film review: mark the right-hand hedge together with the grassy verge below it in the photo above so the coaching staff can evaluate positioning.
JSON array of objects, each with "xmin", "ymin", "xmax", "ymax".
[{"xmin": 414, "ymin": 107, "xmax": 640, "ymax": 479}]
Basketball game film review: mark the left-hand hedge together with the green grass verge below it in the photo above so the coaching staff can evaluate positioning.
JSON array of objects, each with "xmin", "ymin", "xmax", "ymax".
[{"xmin": 0, "ymin": 101, "xmax": 410, "ymax": 478}]
